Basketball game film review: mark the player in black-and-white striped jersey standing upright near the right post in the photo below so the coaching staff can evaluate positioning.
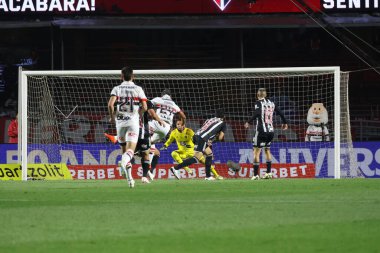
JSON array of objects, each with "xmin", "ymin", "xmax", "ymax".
[{"xmin": 244, "ymin": 88, "xmax": 288, "ymax": 180}]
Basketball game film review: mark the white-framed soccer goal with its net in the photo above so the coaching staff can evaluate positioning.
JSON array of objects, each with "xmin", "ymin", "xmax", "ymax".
[{"xmin": 18, "ymin": 67, "xmax": 360, "ymax": 180}]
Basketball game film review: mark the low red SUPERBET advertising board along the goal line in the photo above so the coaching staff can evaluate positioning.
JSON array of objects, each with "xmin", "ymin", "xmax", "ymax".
[{"xmin": 67, "ymin": 163, "xmax": 315, "ymax": 180}]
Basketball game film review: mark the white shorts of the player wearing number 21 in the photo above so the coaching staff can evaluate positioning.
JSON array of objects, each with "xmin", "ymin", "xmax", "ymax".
[{"xmin": 116, "ymin": 120, "xmax": 140, "ymax": 144}]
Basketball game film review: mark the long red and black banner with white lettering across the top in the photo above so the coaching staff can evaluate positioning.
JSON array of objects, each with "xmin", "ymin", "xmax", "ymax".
[{"xmin": 0, "ymin": 0, "xmax": 380, "ymax": 17}]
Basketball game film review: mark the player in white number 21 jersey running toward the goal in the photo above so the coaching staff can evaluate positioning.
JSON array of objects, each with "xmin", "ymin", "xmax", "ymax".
[{"xmin": 108, "ymin": 67, "xmax": 147, "ymax": 188}]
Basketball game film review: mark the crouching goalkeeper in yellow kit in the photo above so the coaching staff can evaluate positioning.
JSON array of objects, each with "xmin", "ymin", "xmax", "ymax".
[{"xmin": 161, "ymin": 119, "xmax": 223, "ymax": 179}]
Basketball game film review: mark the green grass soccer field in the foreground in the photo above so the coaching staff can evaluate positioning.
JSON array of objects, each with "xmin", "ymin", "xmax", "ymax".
[{"xmin": 0, "ymin": 179, "xmax": 380, "ymax": 253}]
